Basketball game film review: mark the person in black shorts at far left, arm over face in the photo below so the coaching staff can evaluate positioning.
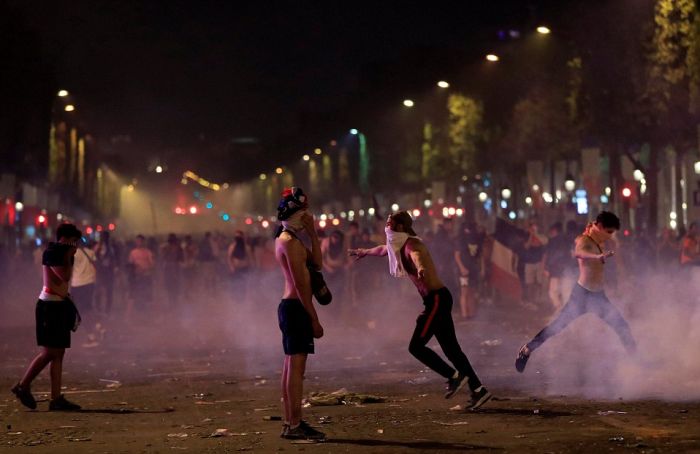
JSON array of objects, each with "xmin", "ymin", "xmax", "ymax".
[{"xmin": 12, "ymin": 224, "xmax": 82, "ymax": 411}]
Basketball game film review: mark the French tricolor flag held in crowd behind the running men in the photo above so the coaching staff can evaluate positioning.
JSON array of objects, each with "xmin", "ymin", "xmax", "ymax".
[{"xmin": 491, "ymin": 218, "xmax": 524, "ymax": 301}]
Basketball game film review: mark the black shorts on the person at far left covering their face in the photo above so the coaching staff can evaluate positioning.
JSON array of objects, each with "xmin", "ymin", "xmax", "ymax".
[{"xmin": 35, "ymin": 300, "xmax": 75, "ymax": 348}]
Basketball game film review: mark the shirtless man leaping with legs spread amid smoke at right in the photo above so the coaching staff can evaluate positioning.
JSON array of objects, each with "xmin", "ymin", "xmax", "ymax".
[{"xmin": 515, "ymin": 211, "xmax": 636, "ymax": 372}]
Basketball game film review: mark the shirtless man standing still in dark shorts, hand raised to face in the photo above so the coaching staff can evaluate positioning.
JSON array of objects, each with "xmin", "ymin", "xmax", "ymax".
[{"xmin": 275, "ymin": 187, "xmax": 326, "ymax": 440}]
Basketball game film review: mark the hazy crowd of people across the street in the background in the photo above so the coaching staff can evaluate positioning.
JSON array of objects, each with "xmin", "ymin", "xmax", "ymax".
[{"xmin": 0, "ymin": 214, "xmax": 700, "ymax": 334}]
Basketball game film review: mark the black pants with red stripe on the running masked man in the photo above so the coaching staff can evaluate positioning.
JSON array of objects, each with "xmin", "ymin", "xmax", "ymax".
[{"xmin": 408, "ymin": 287, "xmax": 481, "ymax": 390}]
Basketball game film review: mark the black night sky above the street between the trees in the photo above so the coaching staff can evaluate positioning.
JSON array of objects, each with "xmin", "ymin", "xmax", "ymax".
[{"xmin": 2, "ymin": 0, "xmax": 565, "ymax": 179}]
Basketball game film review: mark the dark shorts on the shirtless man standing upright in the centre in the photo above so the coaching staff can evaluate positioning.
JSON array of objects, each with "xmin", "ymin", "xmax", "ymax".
[{"xmin": 277, "ymin": 299, "xmax": 314, "ymax": 355}]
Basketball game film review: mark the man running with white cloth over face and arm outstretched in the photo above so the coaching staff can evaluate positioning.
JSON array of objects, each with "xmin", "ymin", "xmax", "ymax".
[{"xmin": 348, "ymin": 211, "xmax": 491, "ymax": 410}]
